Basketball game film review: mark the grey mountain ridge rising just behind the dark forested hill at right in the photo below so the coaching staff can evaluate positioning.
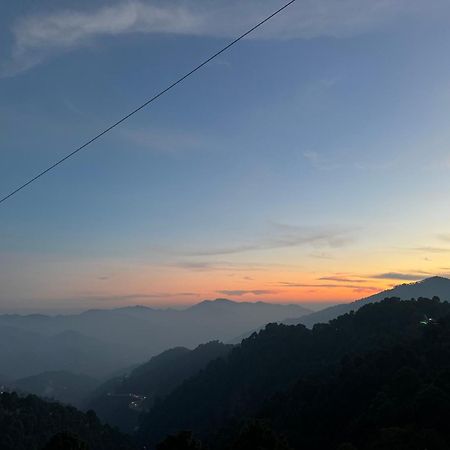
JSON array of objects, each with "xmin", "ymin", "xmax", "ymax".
[{"xmin": 285, "ymin": 277, "xmax": 450, "ymax": 327}]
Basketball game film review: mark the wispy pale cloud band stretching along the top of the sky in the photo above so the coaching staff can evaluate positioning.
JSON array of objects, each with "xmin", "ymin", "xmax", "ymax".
[{"xmin": 3, "ymin": 0, "xmax": 445, "ymax": 75}]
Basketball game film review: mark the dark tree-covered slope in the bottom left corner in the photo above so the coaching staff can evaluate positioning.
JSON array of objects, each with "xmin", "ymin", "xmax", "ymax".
[{"xmin": 0, "ymin": 393, "xmax": 136, "ymax": 450}]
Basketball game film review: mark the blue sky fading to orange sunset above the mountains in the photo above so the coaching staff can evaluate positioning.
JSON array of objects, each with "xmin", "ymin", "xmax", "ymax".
[{"xmin": 0, "ymin": 0, "xmax": 450, "ymax": 312}]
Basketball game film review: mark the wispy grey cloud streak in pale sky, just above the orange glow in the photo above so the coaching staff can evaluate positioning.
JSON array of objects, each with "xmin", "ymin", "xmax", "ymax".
[{"xmin": 167, "ymin": 223, "xmax": 355, "ymax": 256}]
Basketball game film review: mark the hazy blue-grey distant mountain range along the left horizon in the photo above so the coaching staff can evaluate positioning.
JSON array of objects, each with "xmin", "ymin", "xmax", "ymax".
[{"xmin": 0, "ymin": 299, "xmax": 309, "ymax": 378}]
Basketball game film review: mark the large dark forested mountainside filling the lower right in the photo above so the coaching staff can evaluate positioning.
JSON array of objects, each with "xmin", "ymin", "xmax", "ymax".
[{"xmin": 138, "ymin": 298, "xmax": 450, "ymax": 450}]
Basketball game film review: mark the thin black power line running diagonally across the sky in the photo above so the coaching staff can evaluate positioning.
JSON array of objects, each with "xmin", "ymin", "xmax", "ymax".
[{"xmin": 0, "ymin": 0, "xmax": 296, "ymax": 204}]
